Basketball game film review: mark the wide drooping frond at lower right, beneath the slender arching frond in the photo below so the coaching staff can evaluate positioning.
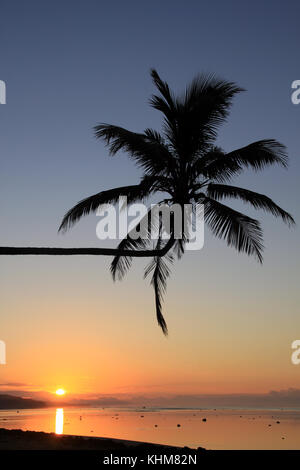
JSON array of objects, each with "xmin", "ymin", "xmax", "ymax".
[{"xmin": 201, "ymin": 195, "xmax": 264, "ymax": 263}]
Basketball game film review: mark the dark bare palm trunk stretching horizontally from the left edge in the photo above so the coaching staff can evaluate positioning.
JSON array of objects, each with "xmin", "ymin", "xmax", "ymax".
[{"xmin": 0, "ymin": 238, "xmax": 175, "ymax": 258}]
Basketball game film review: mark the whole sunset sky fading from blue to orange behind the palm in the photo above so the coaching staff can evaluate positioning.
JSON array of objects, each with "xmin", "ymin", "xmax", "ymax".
[{"xmin": 0, "ymin": 0, "xmax": 300, "ymax": 404}]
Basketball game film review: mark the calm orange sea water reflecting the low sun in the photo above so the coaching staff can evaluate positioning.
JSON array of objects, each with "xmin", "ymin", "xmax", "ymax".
[{"xmin": 0, "ymin": 408, "xmax": 300, "ymax": 449}]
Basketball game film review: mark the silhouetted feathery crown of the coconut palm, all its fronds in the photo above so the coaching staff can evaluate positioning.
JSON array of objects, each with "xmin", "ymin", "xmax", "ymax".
[{"xmin": 59, "ymin": 70, "xmax": 294, "ymax": 334}]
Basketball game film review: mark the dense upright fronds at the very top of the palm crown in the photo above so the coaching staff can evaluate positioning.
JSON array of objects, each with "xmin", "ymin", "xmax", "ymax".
[{"xmin": 150, "ymin": 71, "xmax": 243, "ymax": 160}]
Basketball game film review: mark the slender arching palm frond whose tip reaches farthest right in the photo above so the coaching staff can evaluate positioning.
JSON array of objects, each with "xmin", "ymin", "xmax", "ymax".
[{"xmin": 207, "ymin": 183, "xmax": 295, "ymax": 225}]
